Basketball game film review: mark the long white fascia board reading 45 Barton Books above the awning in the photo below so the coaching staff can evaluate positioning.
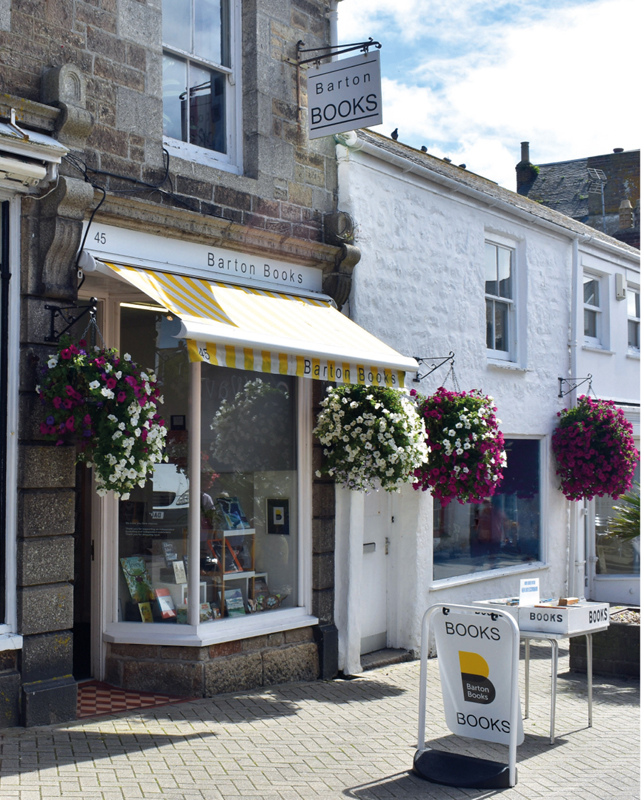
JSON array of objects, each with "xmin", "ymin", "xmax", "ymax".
[{"xmin": 83, "ymin": 222, "xmax": 322, "ymax": 293}]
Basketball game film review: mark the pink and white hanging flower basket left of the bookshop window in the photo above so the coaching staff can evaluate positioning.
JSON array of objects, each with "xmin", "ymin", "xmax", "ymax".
[{"xmin": 36, "ymin": 336, "xmax": 167, "ymax": 500}]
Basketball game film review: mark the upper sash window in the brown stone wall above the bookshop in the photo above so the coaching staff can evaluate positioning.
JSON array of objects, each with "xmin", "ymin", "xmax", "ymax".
[{"xmin": 163, "ymin": 0, "xmax": 237, "ymax": 169}]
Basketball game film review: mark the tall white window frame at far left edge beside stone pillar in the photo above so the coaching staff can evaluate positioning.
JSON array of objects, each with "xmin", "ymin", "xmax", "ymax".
[{"xmin": 0, "ymin": 189, "xmax": 22, "ymax": 650}]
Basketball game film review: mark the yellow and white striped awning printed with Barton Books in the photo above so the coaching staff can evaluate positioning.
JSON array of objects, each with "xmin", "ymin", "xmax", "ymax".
[{"xmin": 106, "ymin": 262, "xmax": 417, "ymax": 387}]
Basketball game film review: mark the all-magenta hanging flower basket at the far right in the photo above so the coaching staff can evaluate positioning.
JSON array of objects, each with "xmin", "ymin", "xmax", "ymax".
[{"xmin": 552, "ymin": 395, "xmax": 639, "ymax": 500}]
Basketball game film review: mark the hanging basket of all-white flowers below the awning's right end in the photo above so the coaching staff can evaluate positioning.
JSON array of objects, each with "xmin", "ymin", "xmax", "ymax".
[{"xmin": 314, "ymin": 384, "xmax": 428, "ymax": 492}]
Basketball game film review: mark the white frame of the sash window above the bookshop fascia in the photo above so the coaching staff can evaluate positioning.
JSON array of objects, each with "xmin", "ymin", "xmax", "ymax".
[{"xmin": 162, "ymin": 0, "xmax": 243, "ymax": 175}]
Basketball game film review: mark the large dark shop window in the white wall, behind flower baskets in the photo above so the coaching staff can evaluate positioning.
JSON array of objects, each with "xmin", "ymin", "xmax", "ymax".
[{"xmin": 433, "ymin": 439, "xmax": 541, "ymax": 580}]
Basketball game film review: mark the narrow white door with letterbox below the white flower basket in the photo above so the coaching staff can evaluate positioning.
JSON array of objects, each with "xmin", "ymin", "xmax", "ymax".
[{"xmin": 360, "ymin": 490, "xmax": 391, "ymax": 655}]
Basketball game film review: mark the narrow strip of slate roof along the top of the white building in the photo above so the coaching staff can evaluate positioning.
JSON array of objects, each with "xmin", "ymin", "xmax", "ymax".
[{"xmin": 357, "ymin": 129, "xmax": 640, "ymax": 259}]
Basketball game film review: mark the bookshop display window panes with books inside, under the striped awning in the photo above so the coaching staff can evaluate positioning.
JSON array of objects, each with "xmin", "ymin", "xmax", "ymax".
[{"xmin": 118, "ymin": 305, "xmax": 299, "ymax": 625}]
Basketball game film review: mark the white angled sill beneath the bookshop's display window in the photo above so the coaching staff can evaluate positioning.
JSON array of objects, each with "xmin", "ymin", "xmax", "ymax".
[{"xmin": 103, "ymin": 608, "xmax": 319, "ymax": 647}]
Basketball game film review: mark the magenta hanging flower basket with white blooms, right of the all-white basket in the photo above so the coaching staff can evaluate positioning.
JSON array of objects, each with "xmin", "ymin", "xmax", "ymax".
[{"xmin": 411, "ymin": 387, "xmax": 507, "ymax": 506}]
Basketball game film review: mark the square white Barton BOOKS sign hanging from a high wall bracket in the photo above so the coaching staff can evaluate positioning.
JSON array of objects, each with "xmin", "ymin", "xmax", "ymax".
[{"xmin": 307, "ymin": 50, "xmax": 382, "ymax": 139}]
